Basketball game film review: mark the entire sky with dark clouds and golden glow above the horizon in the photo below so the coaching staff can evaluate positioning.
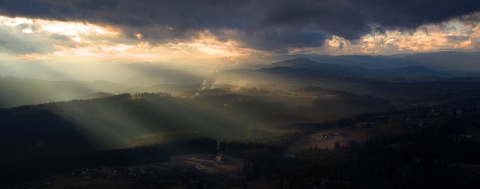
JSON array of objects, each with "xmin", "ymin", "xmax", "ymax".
[{"xmin": 0, "ymin": 0, "xmax": 480, "ymax": 66}]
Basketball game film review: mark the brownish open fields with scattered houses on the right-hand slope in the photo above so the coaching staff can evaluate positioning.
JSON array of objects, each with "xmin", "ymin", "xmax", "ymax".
[{"xmin": 287, "ymin": 111, "xmax": 480, "ymax": 151}]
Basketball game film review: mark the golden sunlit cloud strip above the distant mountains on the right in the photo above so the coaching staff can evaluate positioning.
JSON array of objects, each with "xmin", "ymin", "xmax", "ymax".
[{"xmin": 289, "ymin": 15, "xmax": 480, "ymax": 55}]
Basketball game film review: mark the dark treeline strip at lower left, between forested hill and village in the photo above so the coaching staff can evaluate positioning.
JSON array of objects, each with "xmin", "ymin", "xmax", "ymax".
[{"xmin": 0, "ymin": 138, "xmax": 217, "ymax": 187}]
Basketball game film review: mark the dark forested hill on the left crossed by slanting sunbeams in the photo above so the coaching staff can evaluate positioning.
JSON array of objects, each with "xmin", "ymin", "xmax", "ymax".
[{"xmin": 0, "ymin": 94, "xmax": 244, "ymax": 154}]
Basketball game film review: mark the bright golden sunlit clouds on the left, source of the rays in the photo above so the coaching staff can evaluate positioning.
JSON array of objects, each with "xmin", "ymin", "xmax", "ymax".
[{"xmin": 0, "ymin": 16, "xmax": 253, "ymax": 62}]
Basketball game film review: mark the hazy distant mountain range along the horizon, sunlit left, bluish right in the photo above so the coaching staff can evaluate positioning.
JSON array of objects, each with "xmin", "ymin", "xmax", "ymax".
[{"xmin": 0, "ymin": 52, "xmax": 480, "ymax": 107}]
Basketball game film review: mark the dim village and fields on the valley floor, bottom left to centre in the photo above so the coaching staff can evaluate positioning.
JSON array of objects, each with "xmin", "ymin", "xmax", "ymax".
[{"xmin": 12, "ymin": 154, "xmax": 246, "ymax": 189}]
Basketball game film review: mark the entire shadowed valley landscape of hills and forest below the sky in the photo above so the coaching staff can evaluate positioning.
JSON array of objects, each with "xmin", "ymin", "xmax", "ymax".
[{"xmin": 0, "ymin": 58, "xmax": 480, "ymax": 188}]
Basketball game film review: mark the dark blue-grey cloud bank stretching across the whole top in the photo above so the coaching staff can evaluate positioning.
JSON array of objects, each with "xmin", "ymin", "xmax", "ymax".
[{"xmin": 0, "ymin": 0, "xmax": 480, "ymax": 50}]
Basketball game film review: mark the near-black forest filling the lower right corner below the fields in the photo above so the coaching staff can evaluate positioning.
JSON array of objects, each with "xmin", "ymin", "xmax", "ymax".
[{"xmin": 290, "ymin": 125, "xmax": 480, "ymax": 188}]
